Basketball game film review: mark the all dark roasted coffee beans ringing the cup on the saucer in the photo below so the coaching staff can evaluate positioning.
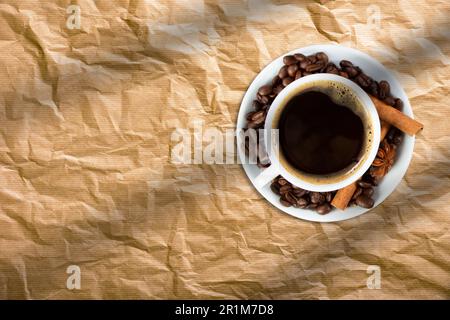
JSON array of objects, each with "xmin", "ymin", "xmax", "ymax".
[{"xmin": 247, "ymin": 52, "xmax": 403, "ymax": 214}]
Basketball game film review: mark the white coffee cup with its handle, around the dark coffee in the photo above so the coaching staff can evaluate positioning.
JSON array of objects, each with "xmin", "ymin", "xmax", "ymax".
[{"xmin": 254, "ymin": 73, "xmax": 380, "ymax": 192}]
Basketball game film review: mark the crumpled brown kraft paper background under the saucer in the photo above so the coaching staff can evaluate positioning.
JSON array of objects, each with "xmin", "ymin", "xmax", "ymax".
[{"xmin": 0, "ymin": 0, "xmax": 450, "ymax": 299}]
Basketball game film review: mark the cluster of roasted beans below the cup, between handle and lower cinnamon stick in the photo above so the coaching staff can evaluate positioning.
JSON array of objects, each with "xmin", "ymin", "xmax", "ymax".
[{"xmin": 270, "ymin": 176, "xmax": 336, "ymax": 214}]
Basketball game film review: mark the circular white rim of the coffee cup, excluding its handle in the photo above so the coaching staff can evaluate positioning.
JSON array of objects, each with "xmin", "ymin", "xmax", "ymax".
[{"xmin": 264, "ymin": 73, "xmax": 381, "ymax": 192}]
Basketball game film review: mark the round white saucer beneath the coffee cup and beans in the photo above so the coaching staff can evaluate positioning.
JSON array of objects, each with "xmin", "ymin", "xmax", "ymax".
[{"xmin": 237, "ymin": 45, "xmax": 415, "ymax": 222}]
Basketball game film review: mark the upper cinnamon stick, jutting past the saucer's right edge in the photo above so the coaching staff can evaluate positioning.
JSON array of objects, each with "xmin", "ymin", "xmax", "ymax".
[{"xmin": 370, "ymin": 95, "xmax": 423, "ymax": 136}]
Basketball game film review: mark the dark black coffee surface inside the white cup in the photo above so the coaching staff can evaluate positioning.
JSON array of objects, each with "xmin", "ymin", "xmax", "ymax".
[{"xmin": 278, "ymin": 91, "xmax": 364, "ymax": 175}]
